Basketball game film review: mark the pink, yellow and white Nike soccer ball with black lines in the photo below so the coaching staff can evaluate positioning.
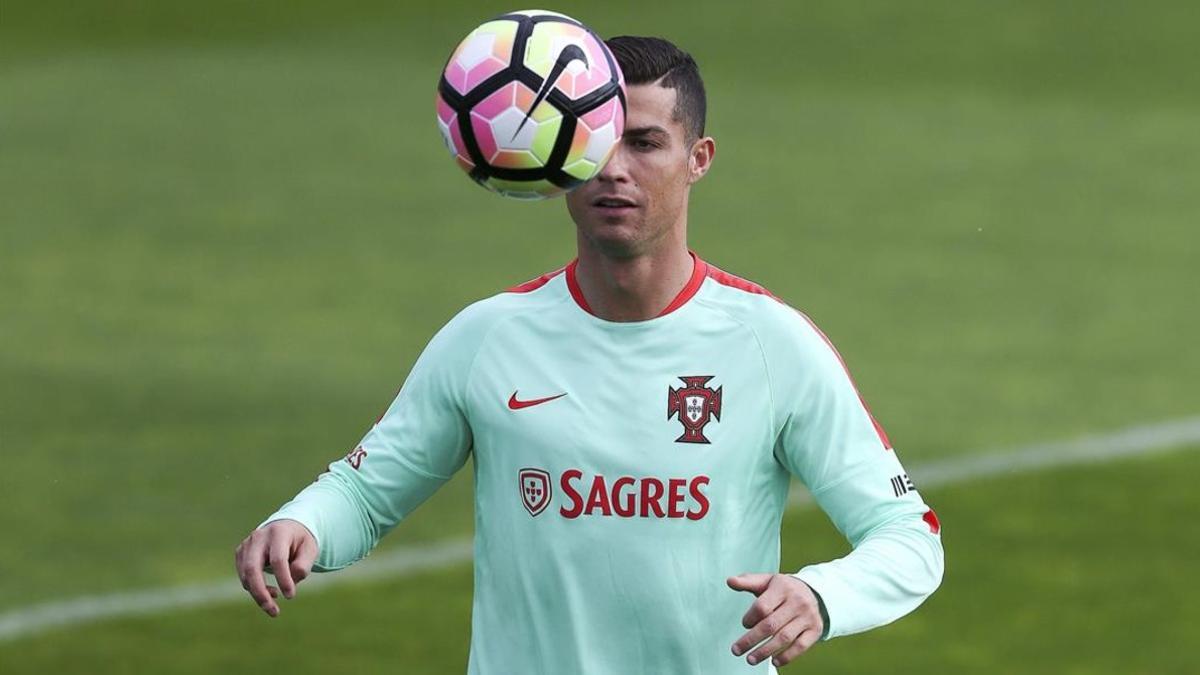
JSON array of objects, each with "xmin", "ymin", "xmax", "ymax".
[{"xmin": 437, "ymin": 10, "xmax": 625, "ymax": 199}]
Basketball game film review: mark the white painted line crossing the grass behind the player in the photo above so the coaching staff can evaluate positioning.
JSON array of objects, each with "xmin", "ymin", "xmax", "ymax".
[{"xmin": 0, "ymin": 417, "xmax": 1200, "ymax": 641}]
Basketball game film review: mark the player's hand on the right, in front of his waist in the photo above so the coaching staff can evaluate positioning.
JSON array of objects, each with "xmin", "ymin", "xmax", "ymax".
[{"xmin": 726, "ymin": 574, "xmax": 824, "ymax": 668}]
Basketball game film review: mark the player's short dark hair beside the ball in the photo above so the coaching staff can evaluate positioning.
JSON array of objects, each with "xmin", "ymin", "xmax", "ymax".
[{"xmin": 605, "ymin": 35, "xmax": 708, "ymax": 142}]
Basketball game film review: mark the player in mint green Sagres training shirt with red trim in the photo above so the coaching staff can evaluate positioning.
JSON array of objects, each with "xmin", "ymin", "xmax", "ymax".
[{"xmin": 236, "ymin": 37, "xmax": 942, "ymax": 675}]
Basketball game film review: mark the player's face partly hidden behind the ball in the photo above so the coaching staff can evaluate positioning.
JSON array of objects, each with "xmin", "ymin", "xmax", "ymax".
[{"xmin": 566, "ymin": 83, "xmax": 713, "ymax": 258}]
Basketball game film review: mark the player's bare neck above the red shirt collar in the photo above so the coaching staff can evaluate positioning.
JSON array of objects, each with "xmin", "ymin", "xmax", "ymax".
[{"xmin": 575, "ymin": 235, "xmax": 694, "ymax": 322}]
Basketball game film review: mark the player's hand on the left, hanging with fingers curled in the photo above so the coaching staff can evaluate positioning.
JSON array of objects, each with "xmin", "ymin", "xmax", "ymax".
[{"xmin": 234, "ymin": 520, "xmax": 317, "ymax": 617}]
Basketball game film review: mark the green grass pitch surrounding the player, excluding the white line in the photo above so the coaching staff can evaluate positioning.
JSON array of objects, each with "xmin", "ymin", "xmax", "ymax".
[{"xmin": 0, "ymin": 0, "xmax": 1200, "ymax": 674}]
